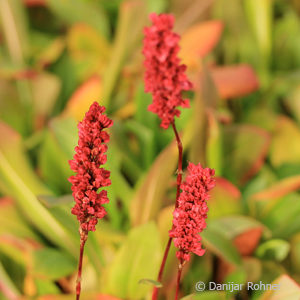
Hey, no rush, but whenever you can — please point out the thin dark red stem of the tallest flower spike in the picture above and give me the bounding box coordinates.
[152,122,183,300]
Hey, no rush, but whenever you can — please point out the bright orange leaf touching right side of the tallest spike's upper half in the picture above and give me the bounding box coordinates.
[180,20,223,67]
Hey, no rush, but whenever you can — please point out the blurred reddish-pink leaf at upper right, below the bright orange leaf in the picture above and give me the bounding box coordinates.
[211,64,259,99]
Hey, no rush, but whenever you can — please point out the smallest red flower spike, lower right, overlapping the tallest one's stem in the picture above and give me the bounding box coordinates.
[169,163,215,261]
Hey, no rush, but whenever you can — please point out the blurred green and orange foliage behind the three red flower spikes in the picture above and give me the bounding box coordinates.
[0,0,300,300]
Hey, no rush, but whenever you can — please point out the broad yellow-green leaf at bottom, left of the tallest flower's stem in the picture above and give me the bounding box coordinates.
[105,223,162,300]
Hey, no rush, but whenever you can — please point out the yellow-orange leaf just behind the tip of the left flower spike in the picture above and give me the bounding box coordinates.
[63,75,102,121]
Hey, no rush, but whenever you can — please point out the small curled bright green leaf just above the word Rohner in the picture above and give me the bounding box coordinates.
[255,239,290,261]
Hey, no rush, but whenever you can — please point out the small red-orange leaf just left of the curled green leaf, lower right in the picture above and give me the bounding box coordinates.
[234,227,263,256]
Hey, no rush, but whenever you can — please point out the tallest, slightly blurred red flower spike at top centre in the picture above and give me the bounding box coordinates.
[143,13,192,129]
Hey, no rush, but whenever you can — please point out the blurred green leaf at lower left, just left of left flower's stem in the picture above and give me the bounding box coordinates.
[32,248,77,280]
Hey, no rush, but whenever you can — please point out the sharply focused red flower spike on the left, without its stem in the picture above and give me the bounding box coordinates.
[69,102,113,232]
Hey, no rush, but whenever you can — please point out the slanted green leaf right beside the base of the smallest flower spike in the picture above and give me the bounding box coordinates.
[201,225,241,266]
